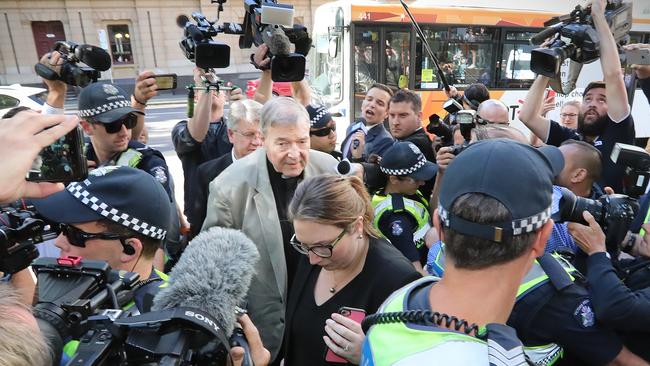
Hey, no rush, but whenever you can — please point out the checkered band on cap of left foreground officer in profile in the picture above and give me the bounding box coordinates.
[66,182,167,239]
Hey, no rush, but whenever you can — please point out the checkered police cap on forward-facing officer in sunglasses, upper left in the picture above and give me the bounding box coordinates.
[79,83,144,123]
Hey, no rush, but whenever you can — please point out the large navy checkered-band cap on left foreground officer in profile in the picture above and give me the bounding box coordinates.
[34,166,171,239]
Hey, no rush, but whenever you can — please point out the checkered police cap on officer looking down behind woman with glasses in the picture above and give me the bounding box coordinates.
[379,141,438,181]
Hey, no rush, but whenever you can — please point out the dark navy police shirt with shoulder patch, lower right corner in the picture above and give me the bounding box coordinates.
[508,276,623,366]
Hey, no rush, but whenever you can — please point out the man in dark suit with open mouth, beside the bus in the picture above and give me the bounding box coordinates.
[341,84,393,161]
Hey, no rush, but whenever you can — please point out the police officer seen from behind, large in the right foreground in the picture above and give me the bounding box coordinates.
[361,139,563,365]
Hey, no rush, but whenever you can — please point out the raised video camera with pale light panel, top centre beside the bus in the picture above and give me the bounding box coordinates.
[239,0,311,81]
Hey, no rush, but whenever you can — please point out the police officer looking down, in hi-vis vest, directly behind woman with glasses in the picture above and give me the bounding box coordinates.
[372,142,437,272]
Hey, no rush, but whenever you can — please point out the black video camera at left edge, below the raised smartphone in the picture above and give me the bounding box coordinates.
[0,206,58,273]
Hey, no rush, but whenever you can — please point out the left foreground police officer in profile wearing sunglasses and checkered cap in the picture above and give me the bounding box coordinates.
[34,166,172,362]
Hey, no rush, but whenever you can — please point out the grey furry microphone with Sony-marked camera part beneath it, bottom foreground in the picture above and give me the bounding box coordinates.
[107,227,259,366]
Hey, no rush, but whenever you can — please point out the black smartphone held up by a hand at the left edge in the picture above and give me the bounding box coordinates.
[26,126,88,183]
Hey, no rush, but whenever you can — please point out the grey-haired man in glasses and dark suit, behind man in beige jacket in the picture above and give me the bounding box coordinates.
[186,100,263,239]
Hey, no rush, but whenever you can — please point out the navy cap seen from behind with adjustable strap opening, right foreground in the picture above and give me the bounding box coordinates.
[438,139,564,242]
